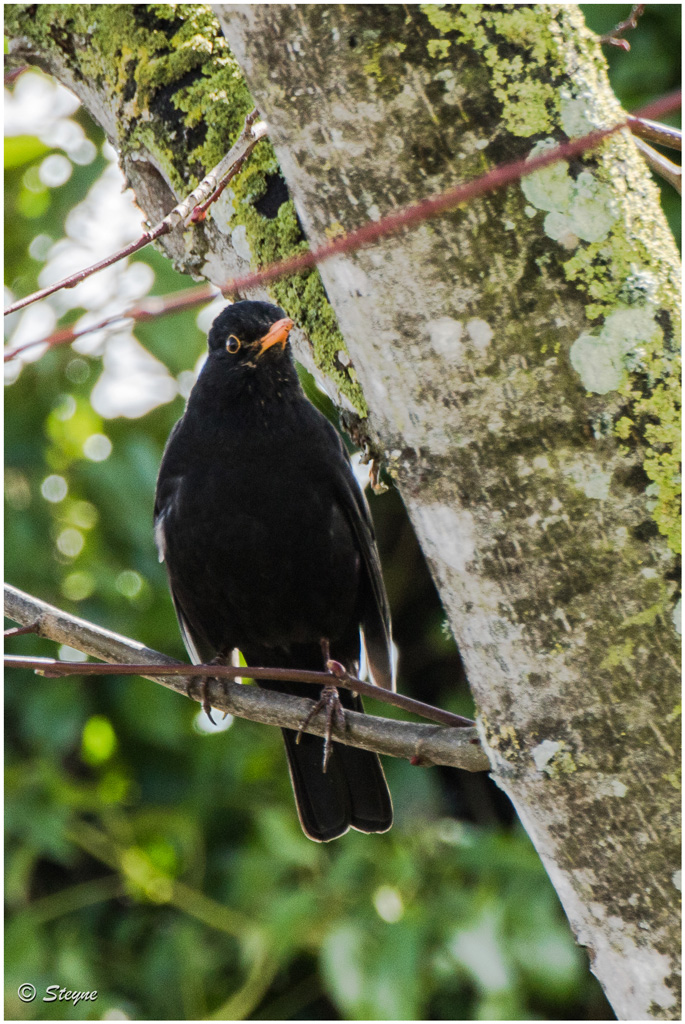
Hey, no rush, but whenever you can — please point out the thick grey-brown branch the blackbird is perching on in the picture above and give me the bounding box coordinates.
[5,584,488,771]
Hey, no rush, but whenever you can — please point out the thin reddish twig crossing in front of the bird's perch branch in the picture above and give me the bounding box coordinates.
[4,651,475,728]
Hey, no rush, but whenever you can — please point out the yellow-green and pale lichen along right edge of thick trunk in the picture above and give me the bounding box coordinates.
[421,4,681,554]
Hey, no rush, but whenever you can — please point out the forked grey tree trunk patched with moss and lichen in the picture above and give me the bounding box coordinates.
[7,4,680,1019]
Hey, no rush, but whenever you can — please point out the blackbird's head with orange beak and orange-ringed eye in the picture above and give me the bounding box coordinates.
[208,301,294,367]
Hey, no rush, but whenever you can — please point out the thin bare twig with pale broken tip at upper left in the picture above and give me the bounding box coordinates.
[5,110,266,316]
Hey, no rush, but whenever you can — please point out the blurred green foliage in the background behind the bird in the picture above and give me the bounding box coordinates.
[5,4,680,1020]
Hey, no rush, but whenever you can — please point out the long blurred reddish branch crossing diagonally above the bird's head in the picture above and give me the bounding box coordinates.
[4,90,682,362]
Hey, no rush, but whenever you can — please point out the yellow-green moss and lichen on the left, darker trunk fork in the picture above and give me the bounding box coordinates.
[5,4,367,417]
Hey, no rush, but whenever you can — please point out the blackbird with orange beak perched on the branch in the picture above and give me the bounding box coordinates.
[155,301,393,842]
